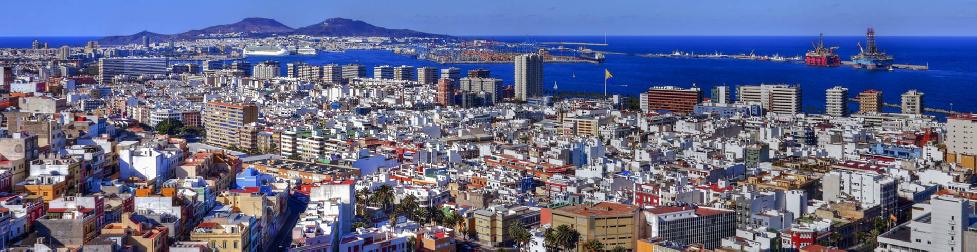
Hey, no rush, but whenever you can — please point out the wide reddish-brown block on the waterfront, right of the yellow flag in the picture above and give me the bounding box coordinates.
[642,86,702,114]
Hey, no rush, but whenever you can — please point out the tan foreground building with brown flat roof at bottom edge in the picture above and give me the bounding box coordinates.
[552,202,638,250]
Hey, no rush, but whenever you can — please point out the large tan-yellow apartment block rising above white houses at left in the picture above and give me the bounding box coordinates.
[203,102,258,148]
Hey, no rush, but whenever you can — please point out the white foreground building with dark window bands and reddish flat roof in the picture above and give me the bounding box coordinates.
[642,206,736,249]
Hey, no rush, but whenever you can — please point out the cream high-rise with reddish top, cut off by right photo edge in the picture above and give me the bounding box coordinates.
[943,114,977,169]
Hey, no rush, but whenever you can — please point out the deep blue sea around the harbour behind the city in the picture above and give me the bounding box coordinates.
[0,36,977,112]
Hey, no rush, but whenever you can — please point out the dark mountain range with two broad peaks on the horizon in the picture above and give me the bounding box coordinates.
[98,17,449,45]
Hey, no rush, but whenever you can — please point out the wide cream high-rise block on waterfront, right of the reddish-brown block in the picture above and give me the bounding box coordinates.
[736,84,801,114]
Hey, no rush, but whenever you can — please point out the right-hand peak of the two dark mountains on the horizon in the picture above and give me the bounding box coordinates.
[293,18,447,37]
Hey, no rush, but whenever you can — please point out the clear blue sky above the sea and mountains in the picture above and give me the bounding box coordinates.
[0,0,977,36]
